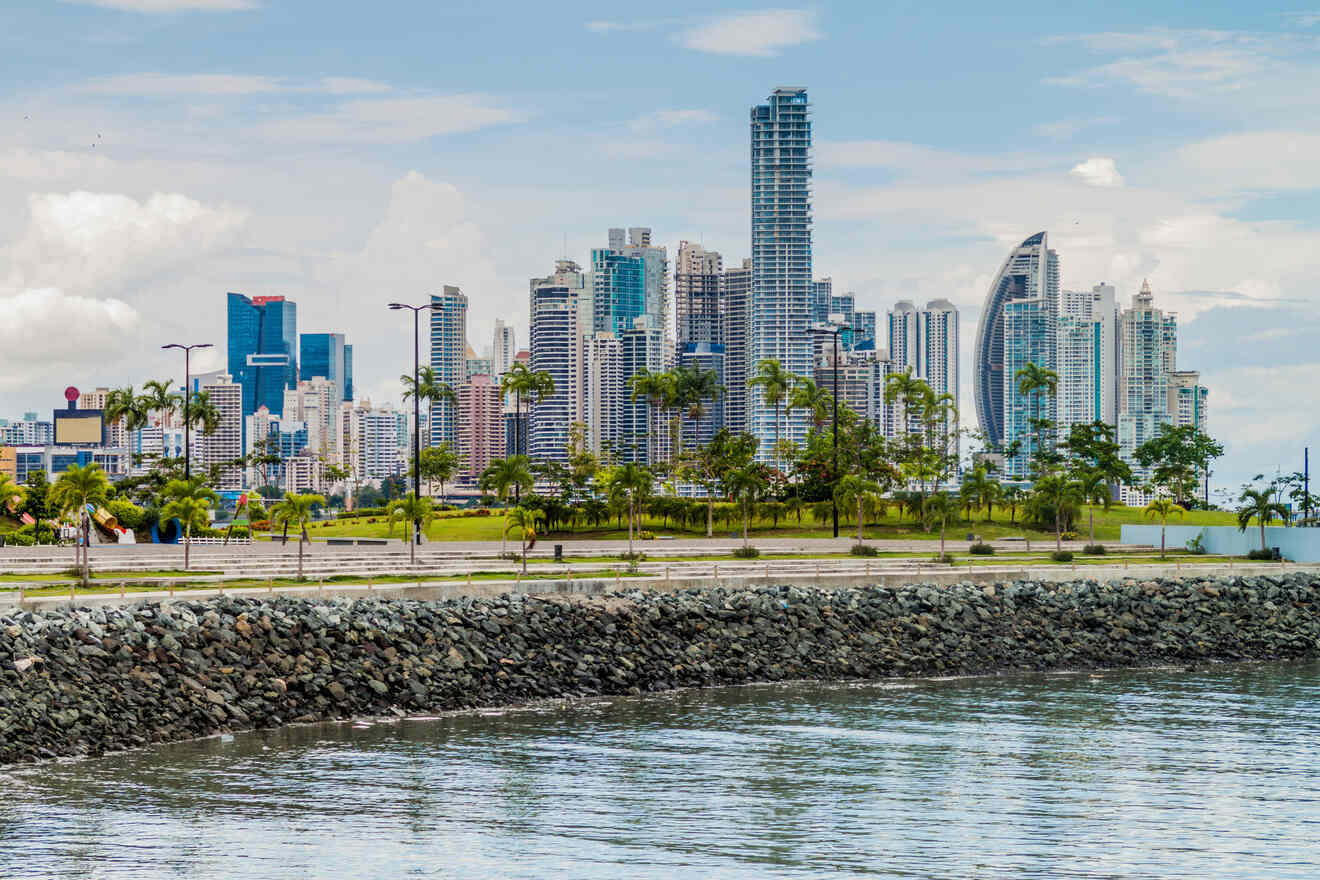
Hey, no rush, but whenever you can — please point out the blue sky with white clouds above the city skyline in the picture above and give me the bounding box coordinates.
[0,0,1320,488]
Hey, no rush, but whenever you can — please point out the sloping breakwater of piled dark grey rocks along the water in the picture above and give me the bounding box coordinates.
[0,574,1320,764]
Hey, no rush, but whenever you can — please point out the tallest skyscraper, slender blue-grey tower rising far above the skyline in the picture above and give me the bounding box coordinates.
[747,88,813,462]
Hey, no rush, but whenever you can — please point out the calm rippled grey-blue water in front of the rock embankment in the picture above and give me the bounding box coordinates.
[0,665,1320,880]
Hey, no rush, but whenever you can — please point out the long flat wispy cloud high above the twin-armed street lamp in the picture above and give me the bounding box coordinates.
[259,95,520,144]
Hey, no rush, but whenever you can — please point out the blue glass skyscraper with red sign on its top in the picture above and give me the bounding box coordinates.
[228,293,298,416]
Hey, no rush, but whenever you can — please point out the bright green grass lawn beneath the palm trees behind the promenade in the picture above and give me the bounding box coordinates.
[294,507,1237,549]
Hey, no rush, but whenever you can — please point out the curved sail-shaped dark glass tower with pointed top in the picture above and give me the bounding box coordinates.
[972,232,1059,450]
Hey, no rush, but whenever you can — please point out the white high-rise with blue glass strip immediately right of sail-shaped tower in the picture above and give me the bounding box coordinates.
[1056,284,1118,439]
